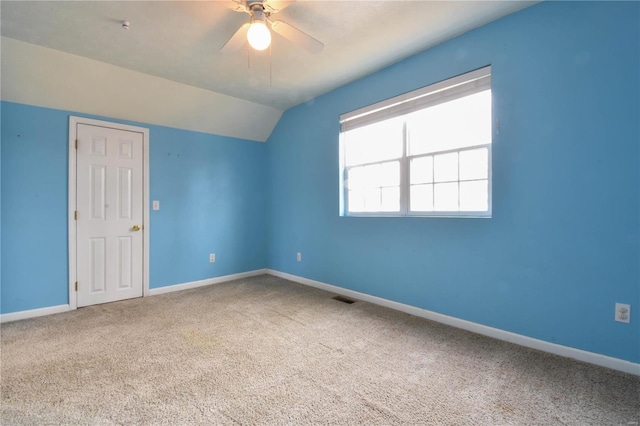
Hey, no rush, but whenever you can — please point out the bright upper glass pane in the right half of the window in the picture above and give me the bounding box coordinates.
[406,90,491,155]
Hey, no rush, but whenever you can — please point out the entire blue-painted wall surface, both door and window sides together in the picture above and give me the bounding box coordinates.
[0,2,640,362]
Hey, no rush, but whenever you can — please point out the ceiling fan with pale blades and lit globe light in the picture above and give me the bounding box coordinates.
[220,0,324,53]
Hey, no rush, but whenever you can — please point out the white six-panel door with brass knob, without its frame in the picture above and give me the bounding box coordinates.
[76,124,144,307]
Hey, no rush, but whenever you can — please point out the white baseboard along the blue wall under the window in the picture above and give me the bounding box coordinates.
[267,269,640,376]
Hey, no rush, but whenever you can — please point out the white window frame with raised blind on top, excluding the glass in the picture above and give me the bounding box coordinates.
[340,66,493,218]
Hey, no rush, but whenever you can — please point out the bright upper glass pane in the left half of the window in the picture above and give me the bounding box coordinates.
[343,117,404,166]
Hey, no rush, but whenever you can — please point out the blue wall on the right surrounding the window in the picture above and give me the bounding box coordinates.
[267,2,640,362]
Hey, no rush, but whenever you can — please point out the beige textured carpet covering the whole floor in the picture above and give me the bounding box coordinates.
[0,276,640,425]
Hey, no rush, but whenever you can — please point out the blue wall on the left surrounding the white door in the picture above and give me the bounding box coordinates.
[0,102,266,313]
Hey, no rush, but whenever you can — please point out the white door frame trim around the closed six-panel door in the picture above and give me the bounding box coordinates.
[67,115,151,309]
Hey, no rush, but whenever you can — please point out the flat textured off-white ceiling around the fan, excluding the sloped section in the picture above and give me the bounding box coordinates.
[0,0,535,110]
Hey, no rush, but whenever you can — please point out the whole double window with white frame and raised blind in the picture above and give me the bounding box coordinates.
[340,67,492,217]
